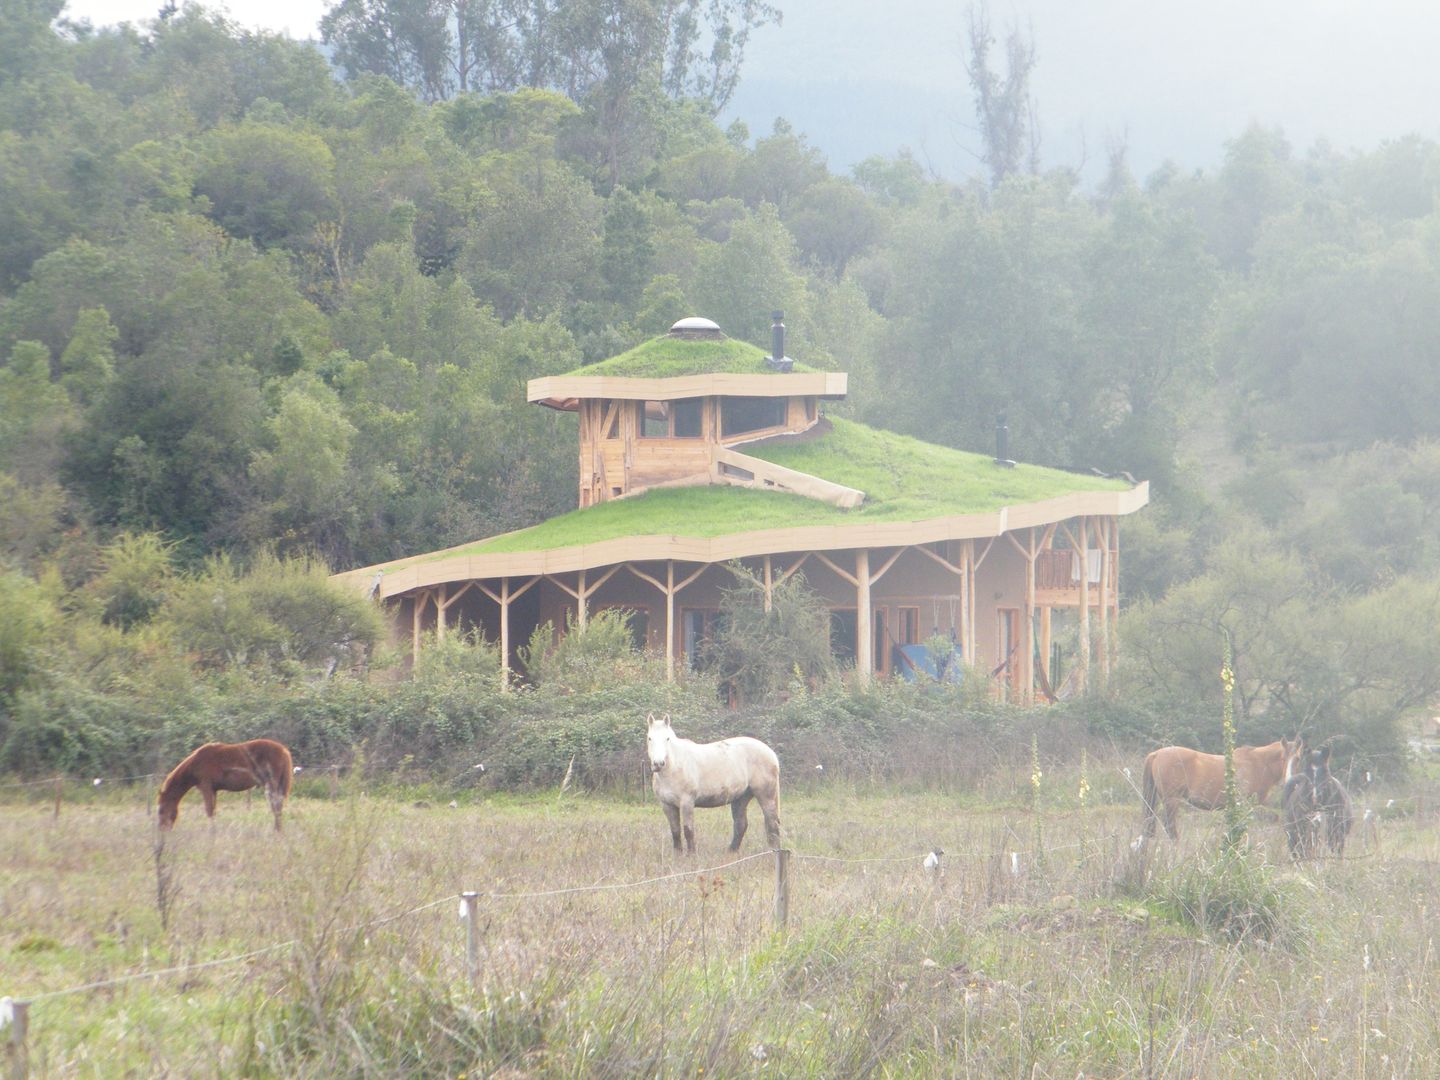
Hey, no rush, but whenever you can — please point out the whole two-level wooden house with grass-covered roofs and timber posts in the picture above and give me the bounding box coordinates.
[337,320,1149,701]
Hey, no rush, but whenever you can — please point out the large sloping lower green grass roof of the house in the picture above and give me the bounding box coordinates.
[420,419,1130,569]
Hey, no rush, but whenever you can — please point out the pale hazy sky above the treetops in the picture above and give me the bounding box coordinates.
[59,0,1440,184]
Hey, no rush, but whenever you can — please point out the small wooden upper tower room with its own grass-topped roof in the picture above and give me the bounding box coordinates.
[527,312,840,507]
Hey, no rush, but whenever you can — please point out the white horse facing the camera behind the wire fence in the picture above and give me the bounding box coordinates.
[645,713,780,855]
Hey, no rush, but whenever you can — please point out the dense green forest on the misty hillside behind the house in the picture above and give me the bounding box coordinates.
[8,0,1440,769]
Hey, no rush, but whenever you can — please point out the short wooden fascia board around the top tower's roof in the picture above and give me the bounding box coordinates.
[526,372,850,412]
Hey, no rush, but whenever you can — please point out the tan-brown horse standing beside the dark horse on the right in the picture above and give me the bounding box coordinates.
[1140,739,1305,842]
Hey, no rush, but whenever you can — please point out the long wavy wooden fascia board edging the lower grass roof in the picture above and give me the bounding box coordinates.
[333,482,1149,599]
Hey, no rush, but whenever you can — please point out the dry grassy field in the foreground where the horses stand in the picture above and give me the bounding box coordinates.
[0,770,1440,1080]
